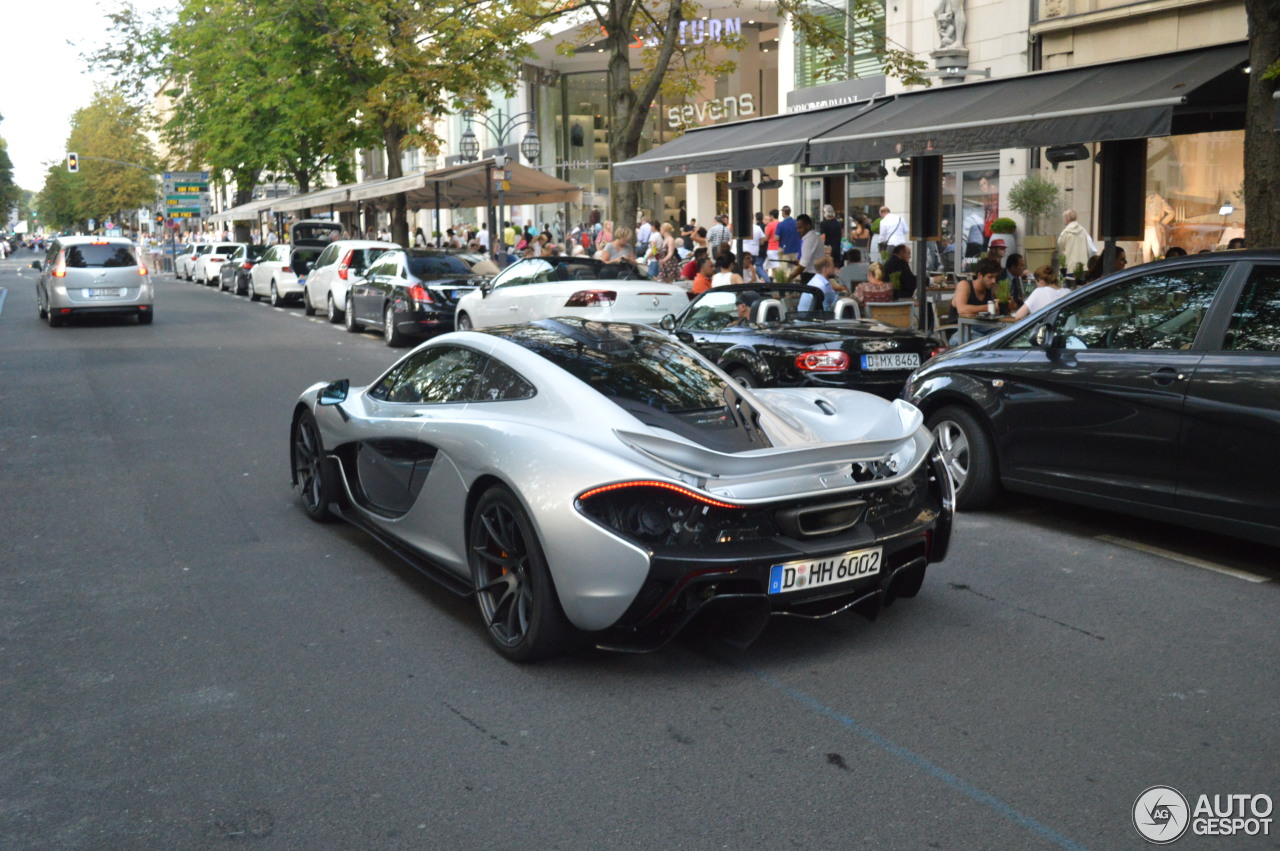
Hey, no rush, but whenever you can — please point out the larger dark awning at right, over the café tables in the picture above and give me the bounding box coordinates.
[797,42,1249,165]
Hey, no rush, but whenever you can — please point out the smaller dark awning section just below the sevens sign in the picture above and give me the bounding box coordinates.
[613,102,868,180]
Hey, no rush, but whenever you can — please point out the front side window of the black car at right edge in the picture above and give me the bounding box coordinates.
[1053,264,1230,351]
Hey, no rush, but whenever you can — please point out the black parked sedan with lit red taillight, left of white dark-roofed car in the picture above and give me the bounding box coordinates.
[344,248,485,347]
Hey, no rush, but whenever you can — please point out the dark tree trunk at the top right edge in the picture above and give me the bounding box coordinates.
[1244,0,1280,248]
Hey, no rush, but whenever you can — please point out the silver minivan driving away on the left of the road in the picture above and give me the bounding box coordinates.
[31,237,155,328]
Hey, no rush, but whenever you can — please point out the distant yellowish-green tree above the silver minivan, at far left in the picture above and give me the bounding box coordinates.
[37,88,157,230]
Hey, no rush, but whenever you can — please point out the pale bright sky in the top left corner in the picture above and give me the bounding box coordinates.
[0,0,173,192]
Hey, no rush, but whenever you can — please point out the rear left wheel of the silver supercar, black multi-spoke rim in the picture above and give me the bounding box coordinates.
[467,485,577,662]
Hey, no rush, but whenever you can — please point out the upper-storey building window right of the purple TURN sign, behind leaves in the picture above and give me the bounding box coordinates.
[796,0,884,88]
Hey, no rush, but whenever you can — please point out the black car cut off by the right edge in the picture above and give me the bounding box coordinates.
[904,251,1280,545]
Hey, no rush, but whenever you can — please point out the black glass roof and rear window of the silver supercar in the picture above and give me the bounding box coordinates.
[493,319,771,452]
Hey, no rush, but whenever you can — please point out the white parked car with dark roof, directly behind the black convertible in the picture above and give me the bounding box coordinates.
[454,257,689,330]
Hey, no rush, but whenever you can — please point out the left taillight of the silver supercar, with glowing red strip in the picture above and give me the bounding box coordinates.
[577,480,769,546]
